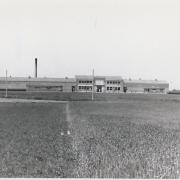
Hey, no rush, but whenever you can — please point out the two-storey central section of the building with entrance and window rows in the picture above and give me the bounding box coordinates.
[76,75,123,93]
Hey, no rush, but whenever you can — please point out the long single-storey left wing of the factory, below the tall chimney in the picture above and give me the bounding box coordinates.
[0,77,76,92]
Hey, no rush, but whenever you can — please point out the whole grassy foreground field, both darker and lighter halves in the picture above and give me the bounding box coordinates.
[0,95,180,178]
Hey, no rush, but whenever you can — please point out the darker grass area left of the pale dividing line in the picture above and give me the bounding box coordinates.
[0,102,75,177]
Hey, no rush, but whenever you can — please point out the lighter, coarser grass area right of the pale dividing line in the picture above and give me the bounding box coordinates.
[71,100,180,178]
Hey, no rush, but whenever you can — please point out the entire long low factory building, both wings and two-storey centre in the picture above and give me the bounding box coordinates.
[0,75,169,94]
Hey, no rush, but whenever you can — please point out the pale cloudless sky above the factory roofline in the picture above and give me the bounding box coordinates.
[0,0,180,89]
